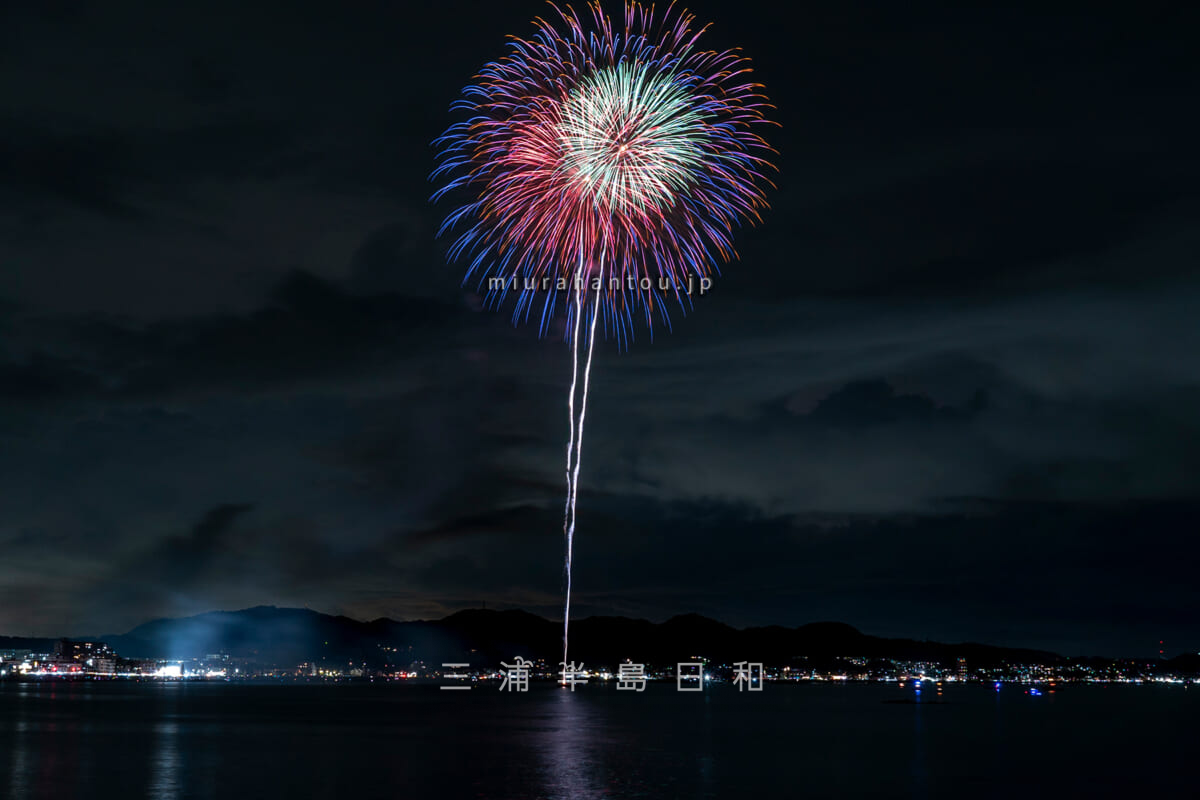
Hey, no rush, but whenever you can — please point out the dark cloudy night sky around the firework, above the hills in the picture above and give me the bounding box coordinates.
[0,0,1200,655]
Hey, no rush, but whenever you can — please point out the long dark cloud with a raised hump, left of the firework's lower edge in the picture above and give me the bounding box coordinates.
[0,271,451,402]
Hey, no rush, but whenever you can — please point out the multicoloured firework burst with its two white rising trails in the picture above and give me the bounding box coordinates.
[431,1,773,669]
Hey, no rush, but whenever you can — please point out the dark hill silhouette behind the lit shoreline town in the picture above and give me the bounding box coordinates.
[0,606,1080,667]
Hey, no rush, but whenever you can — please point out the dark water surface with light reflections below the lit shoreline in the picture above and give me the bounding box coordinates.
[0,681,1200,800]
